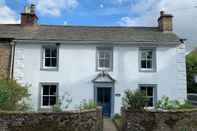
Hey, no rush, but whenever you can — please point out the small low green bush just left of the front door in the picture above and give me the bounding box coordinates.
[80,100,97,110]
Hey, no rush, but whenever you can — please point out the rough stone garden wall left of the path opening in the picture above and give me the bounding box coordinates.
[0,108,103,131]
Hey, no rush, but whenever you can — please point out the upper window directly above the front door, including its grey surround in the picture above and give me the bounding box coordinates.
[96,47,113,71]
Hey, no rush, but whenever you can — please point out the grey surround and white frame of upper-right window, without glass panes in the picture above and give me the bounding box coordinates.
[139,47,156,72]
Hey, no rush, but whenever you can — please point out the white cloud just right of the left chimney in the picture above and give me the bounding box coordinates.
[31,0,79,16]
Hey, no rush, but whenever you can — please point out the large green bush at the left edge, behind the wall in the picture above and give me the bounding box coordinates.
[0,80,30,111]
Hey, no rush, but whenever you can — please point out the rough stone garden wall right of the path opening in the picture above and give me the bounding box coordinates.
[122,109,197,131]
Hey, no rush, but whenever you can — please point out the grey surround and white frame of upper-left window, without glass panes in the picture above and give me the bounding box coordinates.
[41,45,59,70]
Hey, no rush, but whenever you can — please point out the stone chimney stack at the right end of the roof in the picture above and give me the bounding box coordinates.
[158,11,173,32]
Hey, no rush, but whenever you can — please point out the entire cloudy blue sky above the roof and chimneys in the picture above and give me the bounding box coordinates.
[0,0,197,48]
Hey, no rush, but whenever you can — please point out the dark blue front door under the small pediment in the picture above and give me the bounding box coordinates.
[97,88,111,117]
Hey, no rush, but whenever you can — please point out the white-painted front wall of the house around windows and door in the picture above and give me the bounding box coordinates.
[14,43,186,113]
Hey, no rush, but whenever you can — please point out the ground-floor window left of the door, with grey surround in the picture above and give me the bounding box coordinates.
[41,83,58,107]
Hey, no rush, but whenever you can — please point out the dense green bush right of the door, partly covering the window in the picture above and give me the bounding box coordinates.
[122,90,148,110]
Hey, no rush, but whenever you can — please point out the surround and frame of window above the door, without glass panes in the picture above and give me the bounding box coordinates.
[96,47,113,71]
